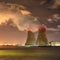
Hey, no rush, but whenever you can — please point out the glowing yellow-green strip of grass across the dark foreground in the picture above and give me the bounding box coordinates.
[0,50,55,56]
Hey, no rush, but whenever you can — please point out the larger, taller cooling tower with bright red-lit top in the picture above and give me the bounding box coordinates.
[36,26,48,46]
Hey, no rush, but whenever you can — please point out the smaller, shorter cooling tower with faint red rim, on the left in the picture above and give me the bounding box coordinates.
[25,31,35,46]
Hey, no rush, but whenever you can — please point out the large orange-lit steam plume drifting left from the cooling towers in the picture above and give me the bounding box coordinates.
[0,3,40,31]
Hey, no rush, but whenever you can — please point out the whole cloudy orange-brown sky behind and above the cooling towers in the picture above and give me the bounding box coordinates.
[0,0,60,44]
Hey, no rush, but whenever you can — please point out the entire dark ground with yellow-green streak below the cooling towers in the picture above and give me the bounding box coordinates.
[0,47,60,60]
